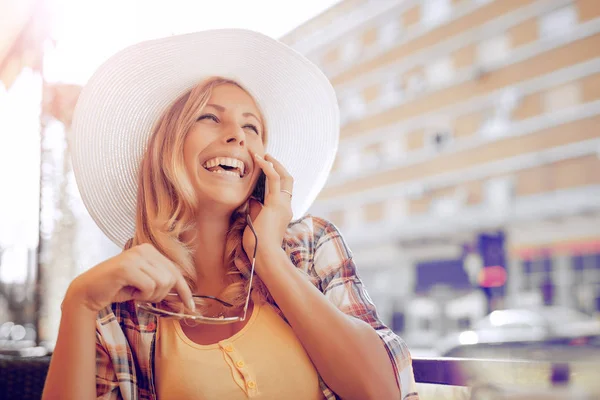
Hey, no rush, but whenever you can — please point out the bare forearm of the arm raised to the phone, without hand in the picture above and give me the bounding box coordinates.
[257,250,400,399]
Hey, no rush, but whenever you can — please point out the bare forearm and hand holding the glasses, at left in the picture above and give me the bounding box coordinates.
[42,244,193,400]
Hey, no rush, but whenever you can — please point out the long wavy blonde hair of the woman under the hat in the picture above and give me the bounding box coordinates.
[125,77,270,308]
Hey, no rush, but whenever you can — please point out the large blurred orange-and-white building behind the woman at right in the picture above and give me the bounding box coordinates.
[283,0,600,345]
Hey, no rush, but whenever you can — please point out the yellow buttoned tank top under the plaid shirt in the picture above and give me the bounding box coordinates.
[155,303,324,400]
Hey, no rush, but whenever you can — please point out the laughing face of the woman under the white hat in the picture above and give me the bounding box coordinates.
[184,84,265,211]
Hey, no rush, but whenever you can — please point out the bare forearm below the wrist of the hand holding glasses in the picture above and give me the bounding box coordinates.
[42,292,96,400]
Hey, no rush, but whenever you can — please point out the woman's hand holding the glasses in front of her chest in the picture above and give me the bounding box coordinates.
[65,243,194,313]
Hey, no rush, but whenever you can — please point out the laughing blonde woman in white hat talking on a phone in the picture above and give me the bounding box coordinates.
[44,29,418,399]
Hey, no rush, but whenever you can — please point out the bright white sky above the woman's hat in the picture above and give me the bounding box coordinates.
[46,0,339,83]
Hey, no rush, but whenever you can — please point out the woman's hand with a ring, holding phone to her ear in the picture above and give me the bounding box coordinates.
[243,154,294,259]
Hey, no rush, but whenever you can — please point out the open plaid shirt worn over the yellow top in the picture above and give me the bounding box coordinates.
[96,216,418,400]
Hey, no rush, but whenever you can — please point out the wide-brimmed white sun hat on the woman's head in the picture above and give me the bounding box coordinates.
[69,29,339,247]
